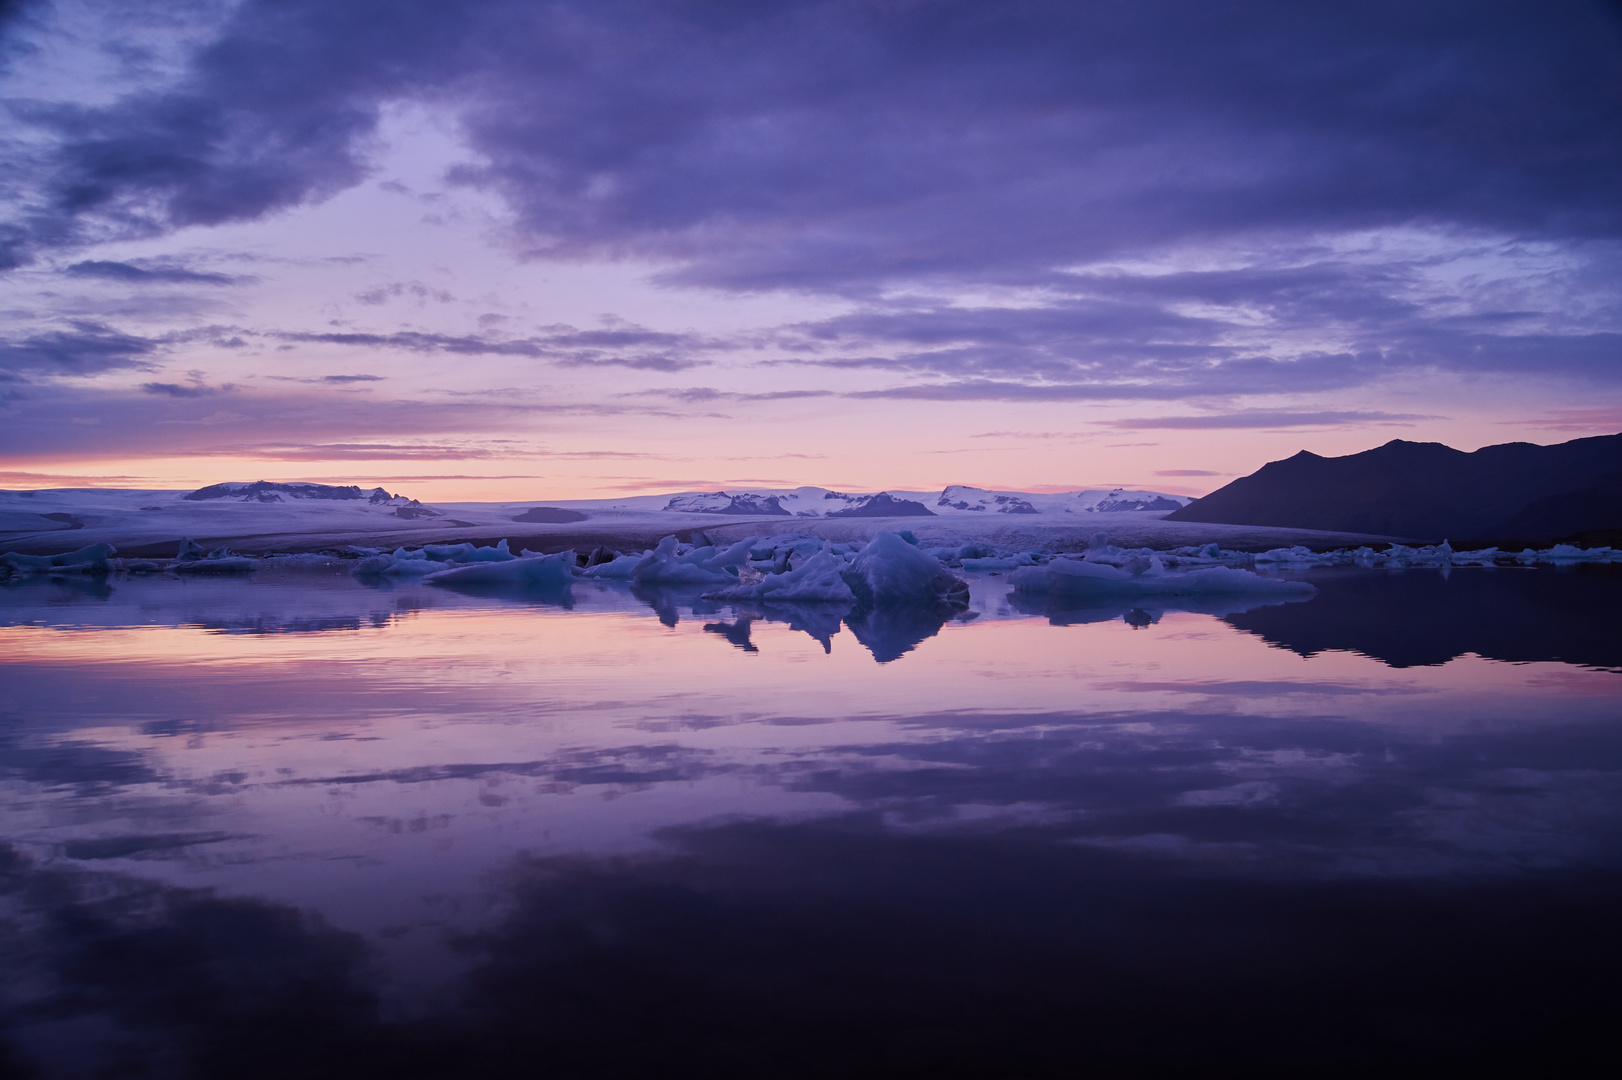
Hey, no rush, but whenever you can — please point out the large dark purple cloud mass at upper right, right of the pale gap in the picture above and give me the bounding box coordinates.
[444,3,1622,289]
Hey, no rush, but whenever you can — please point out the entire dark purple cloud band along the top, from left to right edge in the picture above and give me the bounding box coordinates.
[11,0,1622,277]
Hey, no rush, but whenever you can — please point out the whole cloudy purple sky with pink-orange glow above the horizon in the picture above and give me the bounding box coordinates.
[0,0,1622,501]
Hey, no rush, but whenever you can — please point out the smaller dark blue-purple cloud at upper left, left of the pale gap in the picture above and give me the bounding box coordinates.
[0,3,433,264]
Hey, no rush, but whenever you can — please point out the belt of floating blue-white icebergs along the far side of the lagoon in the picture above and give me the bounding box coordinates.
[9,530,1622,608]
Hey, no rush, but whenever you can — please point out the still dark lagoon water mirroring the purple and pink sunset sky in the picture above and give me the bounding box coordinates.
[0,568,1622,1077]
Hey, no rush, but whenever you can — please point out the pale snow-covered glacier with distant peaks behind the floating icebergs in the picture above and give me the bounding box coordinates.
[0,482,1398,558]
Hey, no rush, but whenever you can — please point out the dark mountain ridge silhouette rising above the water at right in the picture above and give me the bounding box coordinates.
[1166,435,1622,540]
